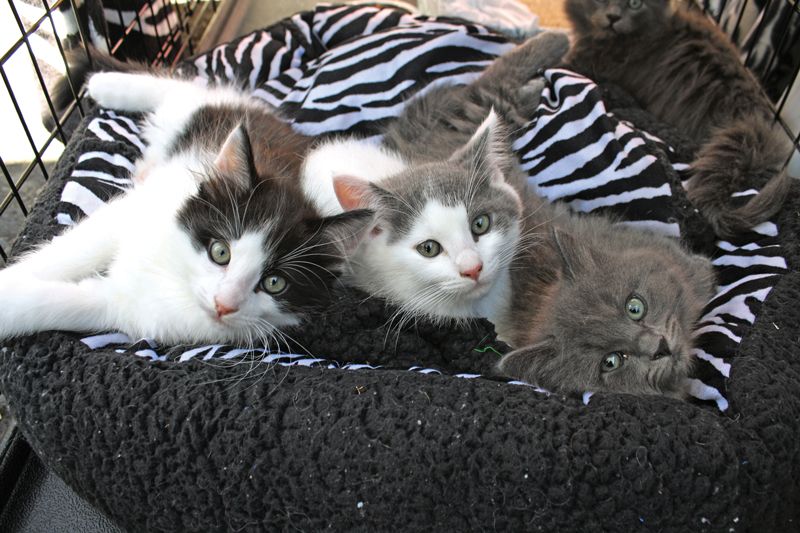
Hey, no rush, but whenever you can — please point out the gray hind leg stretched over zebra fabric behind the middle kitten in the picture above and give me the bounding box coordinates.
[475,31,569,87]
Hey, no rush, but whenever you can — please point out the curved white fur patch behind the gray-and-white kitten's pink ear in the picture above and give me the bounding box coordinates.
[300,139,407,216]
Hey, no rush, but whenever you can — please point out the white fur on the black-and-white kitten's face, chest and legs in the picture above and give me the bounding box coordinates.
[0,74,299,343]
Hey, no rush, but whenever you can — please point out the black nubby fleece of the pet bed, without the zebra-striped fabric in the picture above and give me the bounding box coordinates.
[0,8,800,532]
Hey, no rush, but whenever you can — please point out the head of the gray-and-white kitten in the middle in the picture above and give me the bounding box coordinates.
[324,113,522,320]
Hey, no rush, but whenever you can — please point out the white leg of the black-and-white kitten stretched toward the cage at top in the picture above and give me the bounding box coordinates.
[86,72,203,113]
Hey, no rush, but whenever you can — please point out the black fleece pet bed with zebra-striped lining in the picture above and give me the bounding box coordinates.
[0,5,800,532]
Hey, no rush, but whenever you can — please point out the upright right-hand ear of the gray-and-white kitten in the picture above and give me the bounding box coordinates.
[450,108,508,183]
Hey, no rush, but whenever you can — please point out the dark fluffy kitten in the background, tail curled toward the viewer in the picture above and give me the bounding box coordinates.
[566,0,791,237]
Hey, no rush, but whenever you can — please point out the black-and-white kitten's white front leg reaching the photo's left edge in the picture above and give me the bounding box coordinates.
[0,277,114,339]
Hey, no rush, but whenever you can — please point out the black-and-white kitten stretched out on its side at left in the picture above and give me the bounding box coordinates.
[0,72,370,345]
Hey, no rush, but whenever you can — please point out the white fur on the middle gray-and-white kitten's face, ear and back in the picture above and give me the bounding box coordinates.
[302,110,521,322]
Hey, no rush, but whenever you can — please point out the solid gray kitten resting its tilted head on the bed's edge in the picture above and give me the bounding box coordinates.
[497,202,714,397]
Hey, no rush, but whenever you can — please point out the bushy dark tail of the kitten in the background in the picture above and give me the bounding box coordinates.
[687,119,793,237]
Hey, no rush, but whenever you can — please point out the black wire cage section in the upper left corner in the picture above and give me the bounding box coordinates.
[0,0,222,266]
